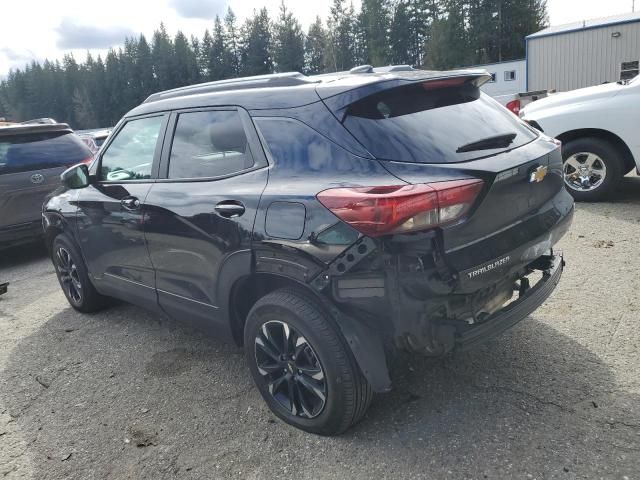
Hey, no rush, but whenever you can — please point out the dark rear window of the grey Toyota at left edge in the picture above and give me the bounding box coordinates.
[0,132,92,175]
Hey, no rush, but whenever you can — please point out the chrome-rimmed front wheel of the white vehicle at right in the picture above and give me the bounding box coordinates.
[562,137,625,202]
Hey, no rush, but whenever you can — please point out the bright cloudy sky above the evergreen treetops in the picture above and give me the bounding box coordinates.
[0,0,640,78]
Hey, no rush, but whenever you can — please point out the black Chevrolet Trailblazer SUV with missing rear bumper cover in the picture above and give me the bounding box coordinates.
[44,67,573,434]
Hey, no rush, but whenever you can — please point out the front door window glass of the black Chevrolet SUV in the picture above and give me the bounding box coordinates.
[100,116,163,182]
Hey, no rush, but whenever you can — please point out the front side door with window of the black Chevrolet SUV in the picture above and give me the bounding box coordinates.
[77,114,168,308]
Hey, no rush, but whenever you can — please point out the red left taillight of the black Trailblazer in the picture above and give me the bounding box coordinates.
[318,179,483,237]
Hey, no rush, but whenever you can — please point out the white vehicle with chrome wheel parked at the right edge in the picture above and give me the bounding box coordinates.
[521,77,640,202]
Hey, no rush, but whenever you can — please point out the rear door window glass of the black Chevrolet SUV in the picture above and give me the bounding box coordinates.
[169,110,253,179]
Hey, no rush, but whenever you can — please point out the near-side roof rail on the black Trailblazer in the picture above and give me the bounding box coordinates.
[143,72,319,103]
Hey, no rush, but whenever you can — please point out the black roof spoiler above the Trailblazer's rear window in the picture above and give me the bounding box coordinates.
[316,70,491,121]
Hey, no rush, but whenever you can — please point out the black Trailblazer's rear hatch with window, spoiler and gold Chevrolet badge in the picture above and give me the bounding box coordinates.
[325,72,572,286]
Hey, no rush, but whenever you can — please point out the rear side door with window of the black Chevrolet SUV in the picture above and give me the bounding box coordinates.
[145,109,267,336]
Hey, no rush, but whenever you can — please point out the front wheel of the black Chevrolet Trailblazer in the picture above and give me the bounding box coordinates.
[51,233,109,313]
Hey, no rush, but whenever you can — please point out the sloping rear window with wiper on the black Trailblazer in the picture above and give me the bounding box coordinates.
[344,82,536,163]
